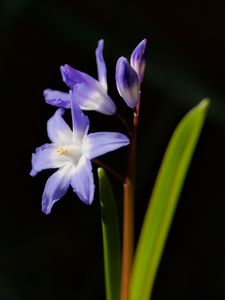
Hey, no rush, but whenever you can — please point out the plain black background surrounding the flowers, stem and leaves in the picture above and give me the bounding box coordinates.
[0,0,225,300]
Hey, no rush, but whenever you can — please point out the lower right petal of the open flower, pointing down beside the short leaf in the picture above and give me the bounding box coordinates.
[71,156,95,204]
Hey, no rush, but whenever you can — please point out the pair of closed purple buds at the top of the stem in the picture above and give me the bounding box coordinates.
[116,39,147,108]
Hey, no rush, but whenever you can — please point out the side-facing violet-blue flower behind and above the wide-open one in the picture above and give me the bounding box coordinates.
[44,40,116,115]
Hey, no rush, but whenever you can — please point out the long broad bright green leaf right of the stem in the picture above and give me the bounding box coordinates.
[130,99,209,300]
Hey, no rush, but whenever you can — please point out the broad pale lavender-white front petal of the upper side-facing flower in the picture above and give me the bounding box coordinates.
[73,83,116,115]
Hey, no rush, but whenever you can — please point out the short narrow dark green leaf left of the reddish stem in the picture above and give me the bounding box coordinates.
[98,168,121,300]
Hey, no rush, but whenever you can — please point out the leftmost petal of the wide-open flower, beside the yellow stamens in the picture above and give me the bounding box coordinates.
[30,144,67,176]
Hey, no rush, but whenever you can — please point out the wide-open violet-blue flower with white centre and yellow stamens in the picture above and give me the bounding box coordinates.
[30,101,129,214]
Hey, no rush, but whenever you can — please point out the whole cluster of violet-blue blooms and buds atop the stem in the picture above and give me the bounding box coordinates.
[30,40,146,214]
